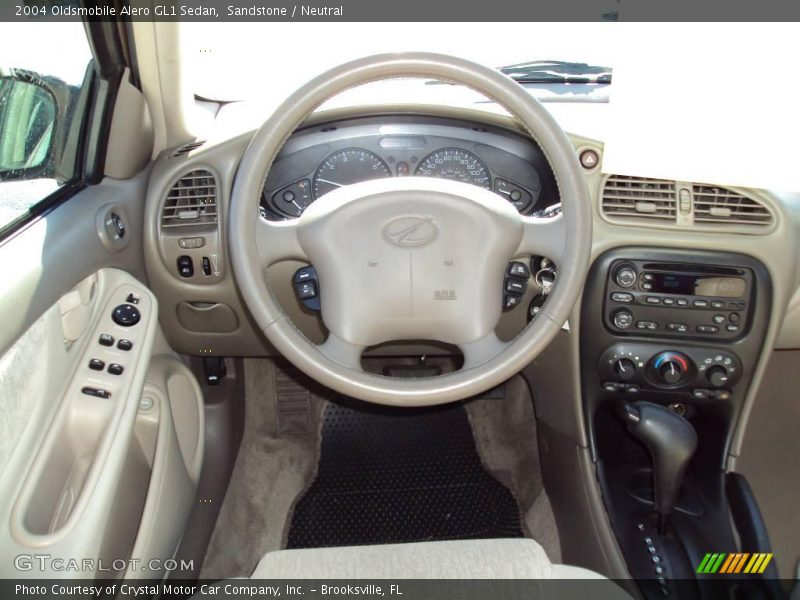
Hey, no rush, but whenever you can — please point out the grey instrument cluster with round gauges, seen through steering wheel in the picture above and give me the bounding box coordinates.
[260,116,559,220]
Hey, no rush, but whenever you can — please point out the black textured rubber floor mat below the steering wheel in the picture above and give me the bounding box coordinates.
[287,403,523,548]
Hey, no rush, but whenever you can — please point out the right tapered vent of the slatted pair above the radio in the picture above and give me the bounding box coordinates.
[692,185,773,227]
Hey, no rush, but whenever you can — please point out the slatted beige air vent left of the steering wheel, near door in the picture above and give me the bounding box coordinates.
[161,169,218,229]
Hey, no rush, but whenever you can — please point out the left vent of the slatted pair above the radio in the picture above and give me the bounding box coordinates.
[602,175,676,222]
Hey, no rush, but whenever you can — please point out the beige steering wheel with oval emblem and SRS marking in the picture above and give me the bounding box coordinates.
[229,53,592,406]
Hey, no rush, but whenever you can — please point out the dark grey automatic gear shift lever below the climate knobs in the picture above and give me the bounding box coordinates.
[623,402,697,533]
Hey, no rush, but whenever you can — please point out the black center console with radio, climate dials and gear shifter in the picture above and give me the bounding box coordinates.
[580,247,777,598]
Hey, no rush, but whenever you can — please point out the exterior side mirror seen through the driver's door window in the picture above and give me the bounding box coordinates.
[0,69,77,181]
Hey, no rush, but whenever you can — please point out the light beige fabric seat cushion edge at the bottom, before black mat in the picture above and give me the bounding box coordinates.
[252,538,616,579]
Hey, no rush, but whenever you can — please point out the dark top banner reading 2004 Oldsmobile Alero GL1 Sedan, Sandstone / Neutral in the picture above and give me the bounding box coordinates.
[0,0,800,21]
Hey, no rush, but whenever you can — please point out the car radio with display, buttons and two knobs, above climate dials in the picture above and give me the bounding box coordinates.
[603,260,754,340]
